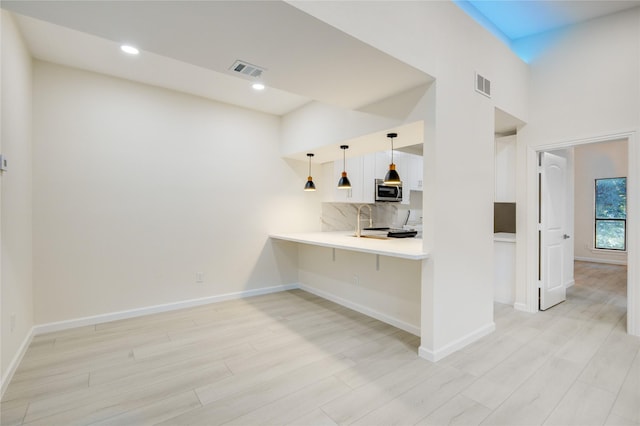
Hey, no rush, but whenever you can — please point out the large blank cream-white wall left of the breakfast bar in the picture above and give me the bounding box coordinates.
[33,62,321,324]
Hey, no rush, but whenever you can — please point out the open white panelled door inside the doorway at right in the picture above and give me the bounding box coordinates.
[540,152,569,311]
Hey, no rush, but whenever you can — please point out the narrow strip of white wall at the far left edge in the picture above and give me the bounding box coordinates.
[0,11,33,390]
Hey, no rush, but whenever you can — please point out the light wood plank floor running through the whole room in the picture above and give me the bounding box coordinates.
[2,262,640,426]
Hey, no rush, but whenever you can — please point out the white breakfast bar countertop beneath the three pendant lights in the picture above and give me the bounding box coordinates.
[269,231,429,260]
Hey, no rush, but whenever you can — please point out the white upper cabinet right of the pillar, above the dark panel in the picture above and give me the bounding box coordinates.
[495,135,517,203]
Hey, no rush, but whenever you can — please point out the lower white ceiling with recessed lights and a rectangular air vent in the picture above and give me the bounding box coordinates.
[2,0,432,115]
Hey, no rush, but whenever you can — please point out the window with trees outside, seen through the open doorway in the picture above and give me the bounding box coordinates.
[595,178,627,250]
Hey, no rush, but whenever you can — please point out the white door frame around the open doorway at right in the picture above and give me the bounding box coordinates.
[514,131,640,336]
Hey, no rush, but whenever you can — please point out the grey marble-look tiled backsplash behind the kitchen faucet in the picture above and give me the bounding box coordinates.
[322,203,416,232]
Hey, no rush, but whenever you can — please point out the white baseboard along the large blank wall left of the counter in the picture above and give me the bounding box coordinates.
[33,284,299,336]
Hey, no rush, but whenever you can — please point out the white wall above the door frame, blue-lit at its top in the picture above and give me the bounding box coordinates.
[519,8,640,145]
